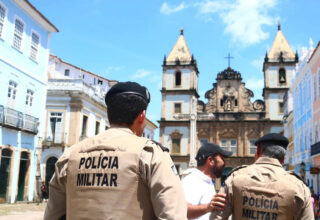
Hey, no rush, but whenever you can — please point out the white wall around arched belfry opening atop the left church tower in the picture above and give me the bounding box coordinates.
[165,69,191,90]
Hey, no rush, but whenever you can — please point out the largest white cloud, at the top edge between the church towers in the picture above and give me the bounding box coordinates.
[196,0,278,46]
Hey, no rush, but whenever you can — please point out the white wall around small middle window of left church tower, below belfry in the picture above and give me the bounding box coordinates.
[164,95,190,120]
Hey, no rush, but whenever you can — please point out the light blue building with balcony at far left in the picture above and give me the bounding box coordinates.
[0,0,58,203]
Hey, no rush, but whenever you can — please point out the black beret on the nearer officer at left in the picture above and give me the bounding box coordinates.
[105,82,150,104]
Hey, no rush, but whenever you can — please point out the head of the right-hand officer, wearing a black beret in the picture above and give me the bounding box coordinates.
[255,133,289,161]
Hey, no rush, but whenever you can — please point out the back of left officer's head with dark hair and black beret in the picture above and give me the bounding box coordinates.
[105,82,150,125]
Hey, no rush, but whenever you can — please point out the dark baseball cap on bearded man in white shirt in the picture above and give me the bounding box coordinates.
[196,143,232,161]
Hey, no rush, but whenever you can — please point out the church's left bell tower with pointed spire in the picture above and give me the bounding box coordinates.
[159,29,199,170]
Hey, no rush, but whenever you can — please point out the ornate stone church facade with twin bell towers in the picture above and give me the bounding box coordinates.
[159,27,297,183]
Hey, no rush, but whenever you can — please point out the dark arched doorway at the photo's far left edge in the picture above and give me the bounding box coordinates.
[0,149,12,203]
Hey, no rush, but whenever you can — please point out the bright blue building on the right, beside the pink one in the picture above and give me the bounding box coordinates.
[291,42,315,188]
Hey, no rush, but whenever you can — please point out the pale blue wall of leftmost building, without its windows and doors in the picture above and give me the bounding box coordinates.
[0,0,51,203]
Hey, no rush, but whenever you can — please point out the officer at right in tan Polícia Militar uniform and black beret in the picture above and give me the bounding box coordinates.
[210,133,314,220]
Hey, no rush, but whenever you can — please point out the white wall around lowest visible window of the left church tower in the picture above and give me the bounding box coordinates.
[163,127,189,155]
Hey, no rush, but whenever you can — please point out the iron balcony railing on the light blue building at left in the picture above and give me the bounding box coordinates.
[0,105,39,133]
